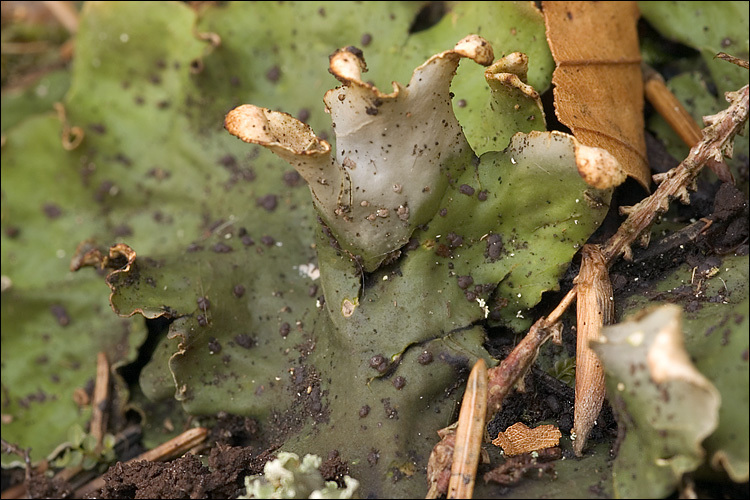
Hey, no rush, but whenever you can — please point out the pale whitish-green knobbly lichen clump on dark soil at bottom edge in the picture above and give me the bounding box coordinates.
[238,451,359,498]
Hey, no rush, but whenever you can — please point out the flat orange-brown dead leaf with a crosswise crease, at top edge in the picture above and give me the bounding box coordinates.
[543,2,651,189]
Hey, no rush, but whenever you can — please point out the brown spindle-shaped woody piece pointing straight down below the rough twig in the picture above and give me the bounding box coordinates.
[573,245,615,456]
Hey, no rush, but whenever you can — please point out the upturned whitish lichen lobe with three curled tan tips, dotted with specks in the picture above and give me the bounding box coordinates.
[225,35,494,271]
